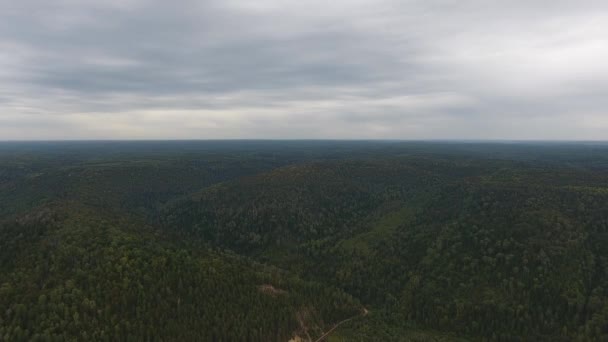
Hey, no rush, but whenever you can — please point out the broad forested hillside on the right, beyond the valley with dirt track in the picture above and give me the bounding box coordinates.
[166,154,608,340]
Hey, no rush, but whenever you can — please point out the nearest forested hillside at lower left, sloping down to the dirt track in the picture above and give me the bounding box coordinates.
[0,203,362,341]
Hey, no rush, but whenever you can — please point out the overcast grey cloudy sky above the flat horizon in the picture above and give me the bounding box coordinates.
[0,0,608,140]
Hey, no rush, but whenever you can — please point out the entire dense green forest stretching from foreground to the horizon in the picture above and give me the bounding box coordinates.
[0,141,608,341]
